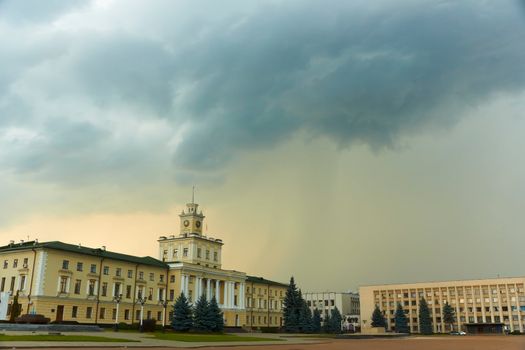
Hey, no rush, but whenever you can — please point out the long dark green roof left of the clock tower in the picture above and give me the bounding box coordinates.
[0,241,168,269]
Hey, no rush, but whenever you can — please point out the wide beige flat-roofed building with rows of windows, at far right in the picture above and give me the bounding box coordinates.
[359,277,525,333]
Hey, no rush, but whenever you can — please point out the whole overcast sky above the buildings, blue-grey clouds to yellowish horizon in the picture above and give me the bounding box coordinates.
[0,0,525,291]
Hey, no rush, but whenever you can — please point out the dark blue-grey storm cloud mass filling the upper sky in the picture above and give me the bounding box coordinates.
[0,1,525,182]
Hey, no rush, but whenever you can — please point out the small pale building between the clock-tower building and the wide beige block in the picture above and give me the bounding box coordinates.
[303,292,360,330]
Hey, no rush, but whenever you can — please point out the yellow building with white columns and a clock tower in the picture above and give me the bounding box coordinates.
[0,203,286,328]
